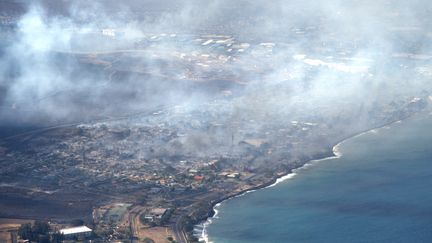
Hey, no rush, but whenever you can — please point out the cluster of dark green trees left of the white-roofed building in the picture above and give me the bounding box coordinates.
[18,220,64,243]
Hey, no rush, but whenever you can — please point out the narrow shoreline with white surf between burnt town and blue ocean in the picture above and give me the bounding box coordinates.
[196,117,408,243]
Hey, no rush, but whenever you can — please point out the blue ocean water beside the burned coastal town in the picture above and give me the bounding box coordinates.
[206,116,432,243]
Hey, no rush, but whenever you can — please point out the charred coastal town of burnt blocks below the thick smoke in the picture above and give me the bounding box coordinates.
[1,80,430,242]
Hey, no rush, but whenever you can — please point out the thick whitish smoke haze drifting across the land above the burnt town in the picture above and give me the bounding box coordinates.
[0,0,432,132]
